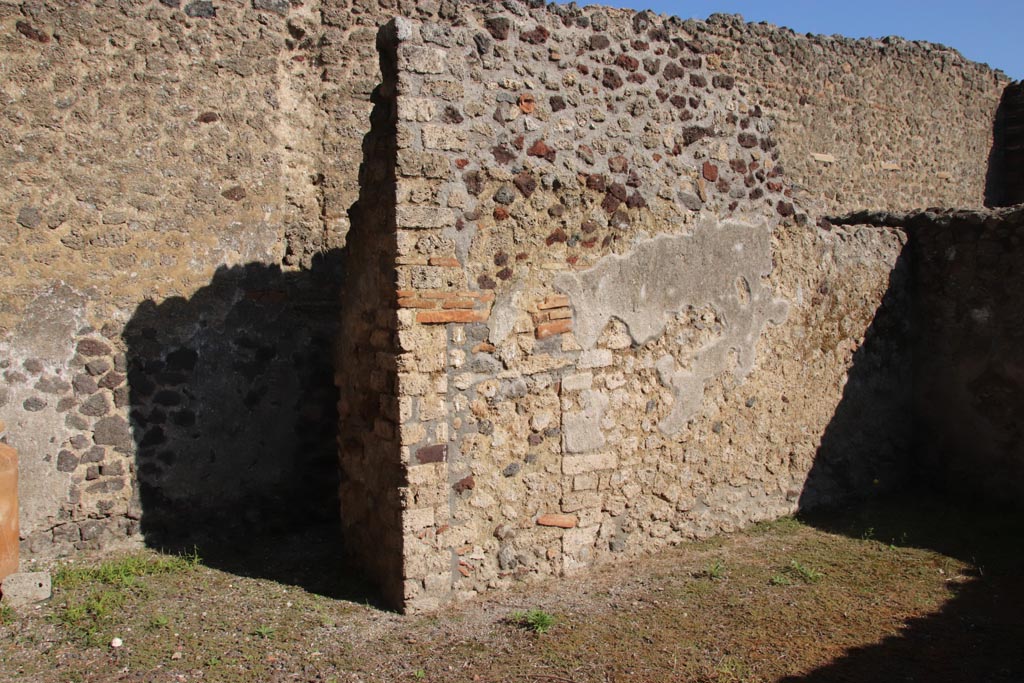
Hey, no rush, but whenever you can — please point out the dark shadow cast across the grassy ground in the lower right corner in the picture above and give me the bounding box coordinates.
[782,492,1024,683]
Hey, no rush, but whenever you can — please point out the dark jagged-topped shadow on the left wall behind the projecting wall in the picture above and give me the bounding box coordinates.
[124,251,373,601]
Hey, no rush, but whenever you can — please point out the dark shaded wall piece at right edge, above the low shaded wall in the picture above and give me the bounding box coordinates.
[985,81,1024,207]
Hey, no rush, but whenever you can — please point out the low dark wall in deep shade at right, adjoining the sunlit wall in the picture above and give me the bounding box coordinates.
[844,207,1024,507]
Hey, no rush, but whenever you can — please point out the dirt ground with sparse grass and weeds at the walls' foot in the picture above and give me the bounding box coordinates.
[0,496,1024,683]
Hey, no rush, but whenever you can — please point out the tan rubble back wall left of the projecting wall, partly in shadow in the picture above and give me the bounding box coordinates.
[0,1,344,556]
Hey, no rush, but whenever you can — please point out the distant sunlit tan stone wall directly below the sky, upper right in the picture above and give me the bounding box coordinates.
[696,15,1009,213]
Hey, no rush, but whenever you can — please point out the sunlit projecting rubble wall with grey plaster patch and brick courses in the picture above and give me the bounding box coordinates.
[385,5,907,610]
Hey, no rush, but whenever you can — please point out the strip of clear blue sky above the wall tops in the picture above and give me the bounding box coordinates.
[584,0,1024,79]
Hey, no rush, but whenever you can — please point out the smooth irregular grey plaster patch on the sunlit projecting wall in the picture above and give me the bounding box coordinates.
[555,216,788,434]
